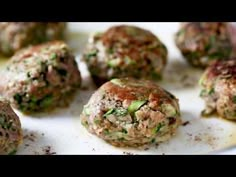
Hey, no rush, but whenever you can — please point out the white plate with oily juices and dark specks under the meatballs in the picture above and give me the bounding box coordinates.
[1,23,236,154]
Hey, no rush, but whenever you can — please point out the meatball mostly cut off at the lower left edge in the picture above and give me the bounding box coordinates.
[0,98,22,155]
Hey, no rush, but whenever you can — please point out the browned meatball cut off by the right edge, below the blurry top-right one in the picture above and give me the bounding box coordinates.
[200,59,236,120]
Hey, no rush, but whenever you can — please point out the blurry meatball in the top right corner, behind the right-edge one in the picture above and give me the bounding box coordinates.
[175,22,233,68]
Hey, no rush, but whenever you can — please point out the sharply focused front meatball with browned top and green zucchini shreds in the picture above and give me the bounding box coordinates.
[81,78,181,147]
